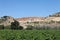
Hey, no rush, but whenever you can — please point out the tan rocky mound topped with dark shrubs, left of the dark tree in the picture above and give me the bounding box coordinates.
[0,16,14,26]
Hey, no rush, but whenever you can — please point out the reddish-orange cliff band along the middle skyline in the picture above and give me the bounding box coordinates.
[16,17,45,22]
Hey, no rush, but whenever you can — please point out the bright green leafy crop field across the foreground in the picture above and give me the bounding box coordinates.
[0,30,60,40]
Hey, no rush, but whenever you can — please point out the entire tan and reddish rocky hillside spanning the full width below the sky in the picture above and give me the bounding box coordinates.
[0,12,60,27]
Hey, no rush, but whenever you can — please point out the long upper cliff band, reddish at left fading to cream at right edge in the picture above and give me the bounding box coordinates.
[16,17,60,23]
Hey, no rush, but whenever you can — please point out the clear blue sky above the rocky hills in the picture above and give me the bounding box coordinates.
[0,0,60,18]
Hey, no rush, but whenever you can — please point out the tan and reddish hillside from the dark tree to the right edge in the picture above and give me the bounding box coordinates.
[16,12,60,28]
